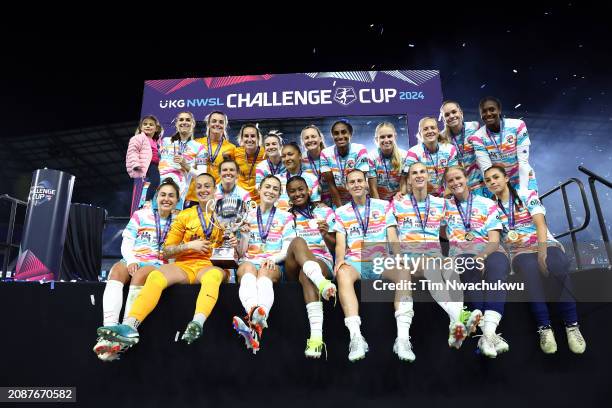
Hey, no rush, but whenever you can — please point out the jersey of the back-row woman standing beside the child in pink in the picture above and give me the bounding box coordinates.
[159,137,208,210]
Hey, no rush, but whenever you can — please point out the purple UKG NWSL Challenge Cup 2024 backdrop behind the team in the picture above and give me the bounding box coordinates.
[142,70,442,149]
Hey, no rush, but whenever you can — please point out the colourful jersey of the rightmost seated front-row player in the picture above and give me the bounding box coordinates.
[497,190,559,255]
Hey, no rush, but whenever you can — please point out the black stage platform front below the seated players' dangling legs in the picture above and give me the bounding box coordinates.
[0,283,612,408]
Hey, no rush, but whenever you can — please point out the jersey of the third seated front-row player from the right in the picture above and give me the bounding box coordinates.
[393,194,445,255]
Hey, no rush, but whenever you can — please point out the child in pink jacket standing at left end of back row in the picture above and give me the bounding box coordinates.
[125,115,164,216]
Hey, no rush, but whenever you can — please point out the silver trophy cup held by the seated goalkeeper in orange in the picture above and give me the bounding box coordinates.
[210,197,246,269]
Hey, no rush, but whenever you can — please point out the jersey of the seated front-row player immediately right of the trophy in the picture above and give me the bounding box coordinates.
[242,207,295,266]
